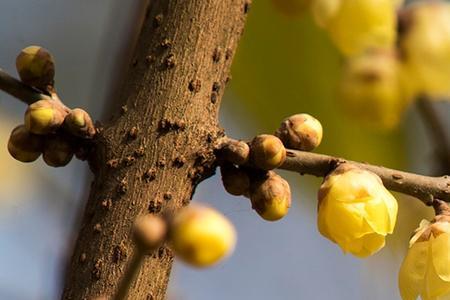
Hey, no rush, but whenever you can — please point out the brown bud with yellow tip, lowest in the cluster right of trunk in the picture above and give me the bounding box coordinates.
[250,171,291,221]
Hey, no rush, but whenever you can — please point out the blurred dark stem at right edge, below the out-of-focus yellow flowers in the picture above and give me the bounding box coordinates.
[417,96,450,173]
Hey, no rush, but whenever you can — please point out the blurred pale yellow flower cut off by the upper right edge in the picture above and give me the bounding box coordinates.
[399,1,450,97]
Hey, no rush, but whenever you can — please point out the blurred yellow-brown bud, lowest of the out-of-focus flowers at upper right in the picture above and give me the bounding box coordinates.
[338,49,411,129]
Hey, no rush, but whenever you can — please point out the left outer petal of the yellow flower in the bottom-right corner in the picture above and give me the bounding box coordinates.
[399,242,430,300]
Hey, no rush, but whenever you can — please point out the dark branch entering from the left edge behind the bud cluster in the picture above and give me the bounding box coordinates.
[0,69,51,104]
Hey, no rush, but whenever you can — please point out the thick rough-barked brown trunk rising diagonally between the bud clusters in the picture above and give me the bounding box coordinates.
[62,0,249,299]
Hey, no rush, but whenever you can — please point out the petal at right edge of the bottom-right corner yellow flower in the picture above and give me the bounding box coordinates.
[431,233,450,282]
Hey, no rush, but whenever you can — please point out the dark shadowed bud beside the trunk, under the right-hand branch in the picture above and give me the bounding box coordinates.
[220,164,250,196]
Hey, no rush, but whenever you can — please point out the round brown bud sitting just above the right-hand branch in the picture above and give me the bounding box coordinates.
[275,114,323,151]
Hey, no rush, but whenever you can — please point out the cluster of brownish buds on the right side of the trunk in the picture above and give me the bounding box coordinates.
[220,114,322,221]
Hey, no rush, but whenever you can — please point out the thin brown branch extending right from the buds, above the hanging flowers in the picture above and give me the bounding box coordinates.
[221,139,450,205]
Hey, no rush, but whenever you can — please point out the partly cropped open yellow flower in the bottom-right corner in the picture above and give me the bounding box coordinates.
[399,216,450,300]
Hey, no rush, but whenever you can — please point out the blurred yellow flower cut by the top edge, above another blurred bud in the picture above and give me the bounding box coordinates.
[311,0,396,55]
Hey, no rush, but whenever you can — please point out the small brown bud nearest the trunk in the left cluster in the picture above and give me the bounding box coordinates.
[64,108,95,138]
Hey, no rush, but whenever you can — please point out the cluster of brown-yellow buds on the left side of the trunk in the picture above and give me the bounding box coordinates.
[8,46,95,167]
